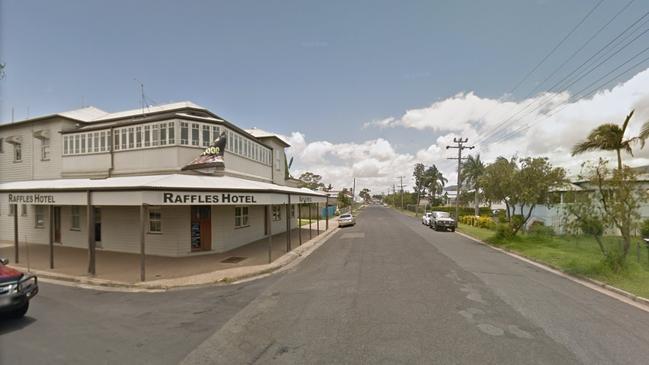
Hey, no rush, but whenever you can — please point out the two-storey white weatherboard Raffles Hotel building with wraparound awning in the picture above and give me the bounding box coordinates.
[0,102,326,273]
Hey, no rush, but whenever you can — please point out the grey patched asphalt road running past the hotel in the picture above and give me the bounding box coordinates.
[0,207,649,364]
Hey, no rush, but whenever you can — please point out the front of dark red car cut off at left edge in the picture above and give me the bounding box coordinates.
[0,259,38,318]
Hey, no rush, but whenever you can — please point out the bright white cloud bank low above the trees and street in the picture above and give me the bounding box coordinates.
[287,70,649,192]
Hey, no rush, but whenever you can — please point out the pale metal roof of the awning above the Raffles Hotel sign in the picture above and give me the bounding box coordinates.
[0,174,326,197]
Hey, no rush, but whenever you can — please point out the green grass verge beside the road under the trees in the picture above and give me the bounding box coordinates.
[458,224,649,298]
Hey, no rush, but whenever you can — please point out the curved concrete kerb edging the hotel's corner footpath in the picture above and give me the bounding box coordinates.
[15,221,339,292]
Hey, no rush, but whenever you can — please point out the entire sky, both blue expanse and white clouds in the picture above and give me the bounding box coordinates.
[0,0,649,193]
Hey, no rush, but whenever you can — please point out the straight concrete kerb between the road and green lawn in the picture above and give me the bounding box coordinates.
[455,232,649,312]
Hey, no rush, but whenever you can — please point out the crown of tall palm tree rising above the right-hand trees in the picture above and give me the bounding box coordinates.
[572,110,649,170]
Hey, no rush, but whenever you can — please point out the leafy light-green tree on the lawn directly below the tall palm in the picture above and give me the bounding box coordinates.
[566,158,649,272]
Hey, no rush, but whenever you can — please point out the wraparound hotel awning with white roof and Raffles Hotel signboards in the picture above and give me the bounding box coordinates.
[0,174,327,205]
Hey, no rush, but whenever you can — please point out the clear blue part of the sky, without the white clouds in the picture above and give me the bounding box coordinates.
[0,0,649,191]
